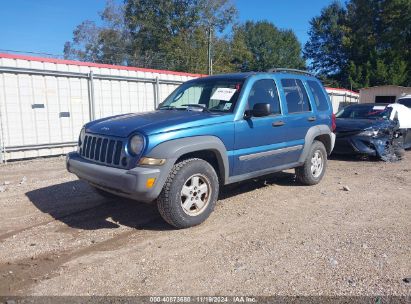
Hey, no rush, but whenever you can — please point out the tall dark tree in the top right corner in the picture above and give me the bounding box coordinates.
[347,0,411,86]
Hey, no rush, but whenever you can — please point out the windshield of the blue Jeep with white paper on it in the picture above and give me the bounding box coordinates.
[158,78,244,112]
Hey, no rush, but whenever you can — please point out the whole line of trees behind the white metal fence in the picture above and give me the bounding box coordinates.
[64,0,411,89]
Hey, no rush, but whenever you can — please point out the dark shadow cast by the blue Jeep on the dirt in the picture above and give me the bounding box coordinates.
[26,172,299,230]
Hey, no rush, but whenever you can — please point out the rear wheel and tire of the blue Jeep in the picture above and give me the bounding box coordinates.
[295,140,327,186]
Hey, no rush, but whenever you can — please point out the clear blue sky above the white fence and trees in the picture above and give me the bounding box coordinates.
[0,0,331,56]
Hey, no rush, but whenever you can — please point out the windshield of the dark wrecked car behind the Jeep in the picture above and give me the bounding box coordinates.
[335,105,391,119]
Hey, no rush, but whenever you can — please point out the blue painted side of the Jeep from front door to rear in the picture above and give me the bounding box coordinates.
[229,73,331,175]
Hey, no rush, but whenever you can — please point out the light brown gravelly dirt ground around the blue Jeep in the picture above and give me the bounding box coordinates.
[0,152,411,296]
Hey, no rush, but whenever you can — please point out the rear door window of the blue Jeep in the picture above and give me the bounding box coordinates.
[281,79,311,113]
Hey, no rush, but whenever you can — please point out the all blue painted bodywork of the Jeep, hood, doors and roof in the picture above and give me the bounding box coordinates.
[86,73,332,176]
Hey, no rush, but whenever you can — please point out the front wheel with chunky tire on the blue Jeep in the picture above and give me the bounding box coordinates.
[157,158,219,229]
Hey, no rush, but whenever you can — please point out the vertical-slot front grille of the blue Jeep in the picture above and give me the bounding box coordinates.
[80,134,123,166]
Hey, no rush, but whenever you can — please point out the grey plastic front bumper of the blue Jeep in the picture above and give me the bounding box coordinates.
[66,152,168,203]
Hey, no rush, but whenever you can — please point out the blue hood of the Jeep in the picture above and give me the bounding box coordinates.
[86,110,227,137]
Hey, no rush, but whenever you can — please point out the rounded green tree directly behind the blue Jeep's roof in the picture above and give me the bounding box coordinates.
[232,21,305,71]
